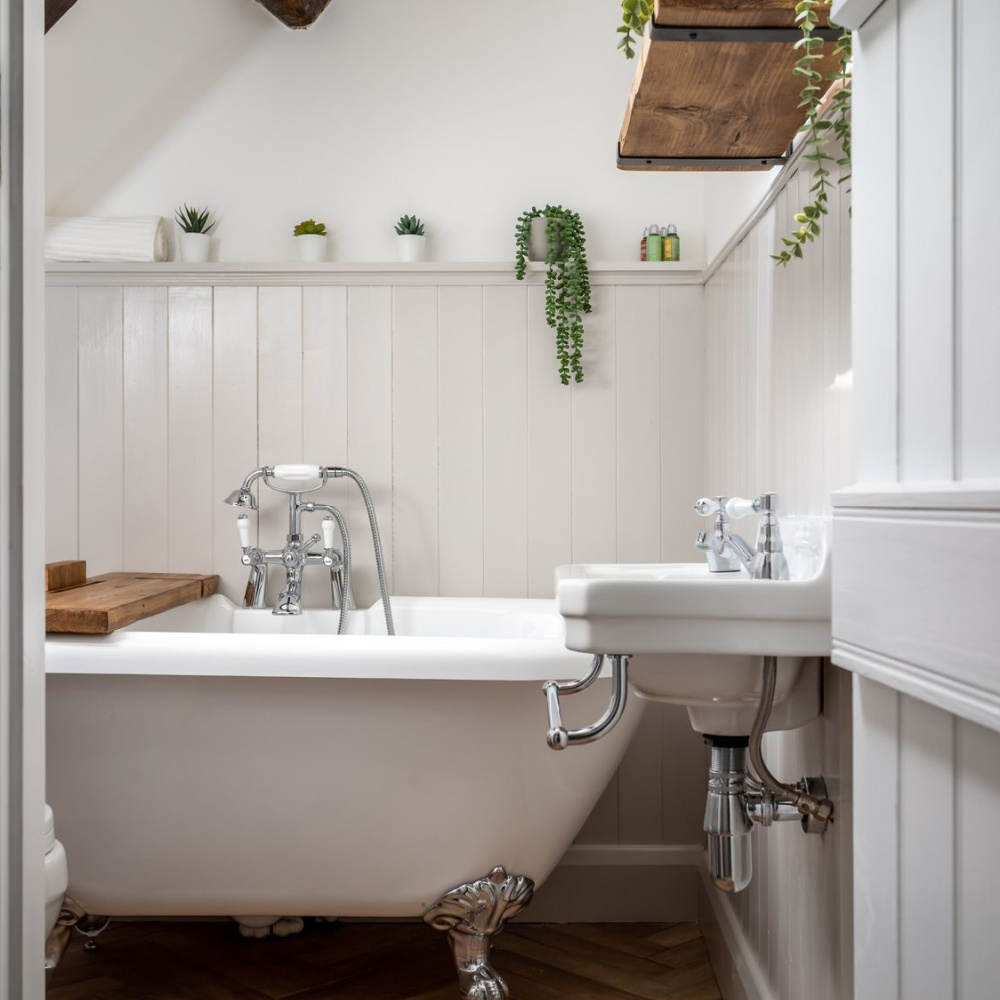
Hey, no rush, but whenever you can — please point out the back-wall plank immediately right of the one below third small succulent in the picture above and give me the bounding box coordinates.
[437,287,484,597]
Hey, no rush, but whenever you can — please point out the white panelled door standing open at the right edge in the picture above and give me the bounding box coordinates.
[833,0,1000,1000]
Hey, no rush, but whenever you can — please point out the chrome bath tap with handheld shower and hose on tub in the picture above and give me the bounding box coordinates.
[225,465,395,635]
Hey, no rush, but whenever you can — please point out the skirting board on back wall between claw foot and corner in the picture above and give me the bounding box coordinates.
[518,844,704,923]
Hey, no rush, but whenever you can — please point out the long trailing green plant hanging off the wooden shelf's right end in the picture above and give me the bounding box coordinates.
[771,0,851,267]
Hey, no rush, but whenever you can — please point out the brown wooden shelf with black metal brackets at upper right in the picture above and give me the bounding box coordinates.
[618,0,837,170]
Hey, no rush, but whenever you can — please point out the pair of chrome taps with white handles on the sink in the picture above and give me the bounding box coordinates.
[694,493,788,580]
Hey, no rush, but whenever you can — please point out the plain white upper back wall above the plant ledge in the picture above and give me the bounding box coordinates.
[46,0,728,261]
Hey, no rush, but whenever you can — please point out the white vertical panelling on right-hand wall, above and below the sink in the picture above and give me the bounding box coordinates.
[703,156,856,1000]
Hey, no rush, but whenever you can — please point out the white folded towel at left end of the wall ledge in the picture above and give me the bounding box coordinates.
[45,215,170,263]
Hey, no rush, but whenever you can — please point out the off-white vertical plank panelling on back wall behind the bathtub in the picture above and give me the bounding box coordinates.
[46,272,705,856]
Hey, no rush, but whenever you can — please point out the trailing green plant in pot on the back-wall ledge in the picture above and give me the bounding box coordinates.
[514,205,591,385]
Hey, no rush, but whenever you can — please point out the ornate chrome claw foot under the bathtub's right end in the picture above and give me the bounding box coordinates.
[424,865,535,1000]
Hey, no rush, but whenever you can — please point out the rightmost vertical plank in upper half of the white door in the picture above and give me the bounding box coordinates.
[955,0,1000,479]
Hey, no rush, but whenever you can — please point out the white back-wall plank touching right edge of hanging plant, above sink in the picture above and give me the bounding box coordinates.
[572,288,618,562]
